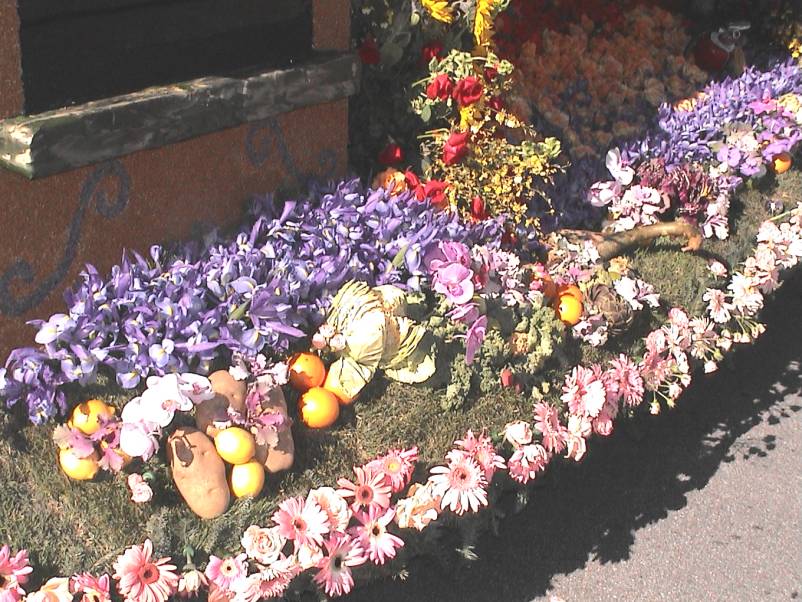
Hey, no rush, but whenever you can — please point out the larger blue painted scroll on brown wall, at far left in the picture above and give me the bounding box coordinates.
[0,161,131,316]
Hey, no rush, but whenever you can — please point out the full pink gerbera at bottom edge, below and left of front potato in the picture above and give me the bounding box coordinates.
[114,539,178,602]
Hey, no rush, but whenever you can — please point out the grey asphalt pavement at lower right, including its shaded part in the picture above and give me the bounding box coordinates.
[349,273,802,602]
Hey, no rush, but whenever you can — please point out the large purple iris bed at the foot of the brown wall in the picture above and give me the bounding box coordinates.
[0,180,502,424]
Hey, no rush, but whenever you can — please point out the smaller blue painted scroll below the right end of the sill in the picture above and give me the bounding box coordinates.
[245,117,337,188]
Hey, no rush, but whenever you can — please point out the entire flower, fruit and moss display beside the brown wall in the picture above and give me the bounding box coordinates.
[0,0,802,601]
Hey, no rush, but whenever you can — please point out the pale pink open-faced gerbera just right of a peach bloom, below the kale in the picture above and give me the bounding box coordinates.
[429,450,487,514]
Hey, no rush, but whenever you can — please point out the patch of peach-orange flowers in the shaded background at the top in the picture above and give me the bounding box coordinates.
[517,6,707,159]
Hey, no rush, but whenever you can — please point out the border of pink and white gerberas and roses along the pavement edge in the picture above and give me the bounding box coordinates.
[6,196,802,601]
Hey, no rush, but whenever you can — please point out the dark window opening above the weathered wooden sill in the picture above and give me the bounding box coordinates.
[18,0,312,114]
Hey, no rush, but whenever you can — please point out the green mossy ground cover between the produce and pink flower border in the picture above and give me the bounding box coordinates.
[0,170,802,581]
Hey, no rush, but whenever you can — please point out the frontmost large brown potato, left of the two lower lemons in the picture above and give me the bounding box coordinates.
[167,427,231,518]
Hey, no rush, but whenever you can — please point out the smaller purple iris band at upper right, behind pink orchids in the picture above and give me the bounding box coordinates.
[622,59,802,166]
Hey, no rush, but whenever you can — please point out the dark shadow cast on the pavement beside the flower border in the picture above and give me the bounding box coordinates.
[349,271,802,602]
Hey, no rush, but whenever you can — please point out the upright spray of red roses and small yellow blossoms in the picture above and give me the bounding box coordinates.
[412,50,561,224]
